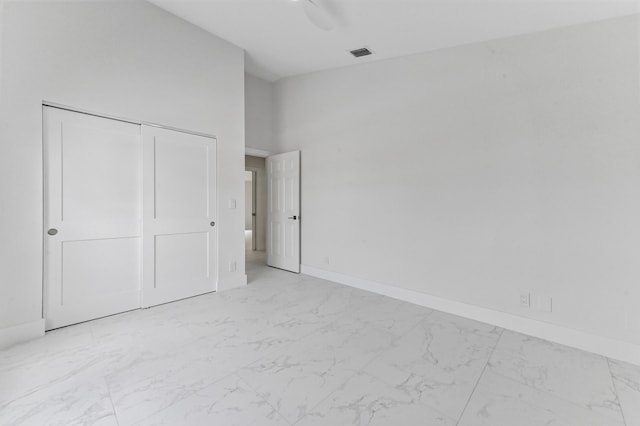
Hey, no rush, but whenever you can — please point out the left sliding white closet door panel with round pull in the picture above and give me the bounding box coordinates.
[43,107,142,330]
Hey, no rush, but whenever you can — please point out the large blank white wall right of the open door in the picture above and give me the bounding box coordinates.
[274,17,640,350]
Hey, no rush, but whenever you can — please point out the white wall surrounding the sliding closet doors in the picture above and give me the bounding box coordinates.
[0,1,246,344]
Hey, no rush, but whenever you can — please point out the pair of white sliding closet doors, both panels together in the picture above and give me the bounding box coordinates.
[43,107,217,330]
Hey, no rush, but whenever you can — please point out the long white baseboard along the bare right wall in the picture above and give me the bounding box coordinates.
[301,265,640,365]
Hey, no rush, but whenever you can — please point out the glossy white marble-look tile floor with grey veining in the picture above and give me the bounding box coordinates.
[0,251,640,426]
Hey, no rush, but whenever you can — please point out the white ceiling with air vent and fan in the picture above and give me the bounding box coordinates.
[151,0,638,81]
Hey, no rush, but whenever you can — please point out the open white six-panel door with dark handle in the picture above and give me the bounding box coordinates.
[267,151,300,272]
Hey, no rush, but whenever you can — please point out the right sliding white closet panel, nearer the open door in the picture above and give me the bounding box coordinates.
[142,125,217,307]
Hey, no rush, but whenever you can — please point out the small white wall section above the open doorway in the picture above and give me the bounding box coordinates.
[245,74,273,151]
